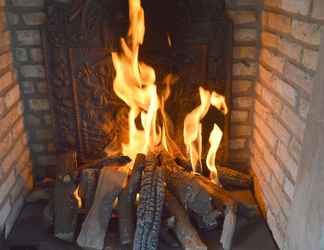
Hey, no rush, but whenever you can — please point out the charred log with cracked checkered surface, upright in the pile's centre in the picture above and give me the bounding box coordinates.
[133,155,165,250]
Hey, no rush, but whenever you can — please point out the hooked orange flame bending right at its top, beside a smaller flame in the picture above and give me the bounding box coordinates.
[183,87,228,171]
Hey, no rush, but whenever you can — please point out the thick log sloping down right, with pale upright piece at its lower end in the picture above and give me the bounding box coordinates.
[161,153,238,250]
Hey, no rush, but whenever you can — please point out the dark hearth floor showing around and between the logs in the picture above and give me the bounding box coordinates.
[8,203,278,250]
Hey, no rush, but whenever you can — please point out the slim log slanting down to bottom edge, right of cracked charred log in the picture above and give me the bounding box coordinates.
[165,189,207,250]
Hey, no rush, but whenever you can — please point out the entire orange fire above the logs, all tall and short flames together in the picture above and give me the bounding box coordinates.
[112,0,228,184]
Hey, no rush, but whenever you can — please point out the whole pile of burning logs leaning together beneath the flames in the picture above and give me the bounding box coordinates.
[54,152,256,250]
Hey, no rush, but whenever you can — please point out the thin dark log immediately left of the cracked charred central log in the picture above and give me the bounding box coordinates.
[118,154,145,250]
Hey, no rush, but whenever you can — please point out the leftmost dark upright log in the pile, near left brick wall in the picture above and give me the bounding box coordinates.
[54,152,77,241]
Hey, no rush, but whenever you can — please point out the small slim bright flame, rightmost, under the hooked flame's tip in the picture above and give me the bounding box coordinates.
[206,124,223,184]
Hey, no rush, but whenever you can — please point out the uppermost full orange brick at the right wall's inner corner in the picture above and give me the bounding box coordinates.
[262,12,292,33]
